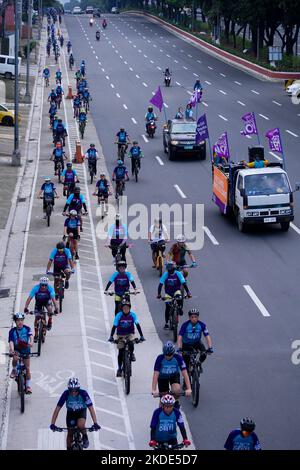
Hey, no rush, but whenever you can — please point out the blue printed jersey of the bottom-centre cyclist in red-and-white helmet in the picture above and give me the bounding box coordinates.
[150,408,184,442]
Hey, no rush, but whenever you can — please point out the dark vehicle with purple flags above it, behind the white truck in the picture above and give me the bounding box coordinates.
[163,119,206,160]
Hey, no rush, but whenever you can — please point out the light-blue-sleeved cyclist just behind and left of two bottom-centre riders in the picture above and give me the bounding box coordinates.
[108,299,145,377]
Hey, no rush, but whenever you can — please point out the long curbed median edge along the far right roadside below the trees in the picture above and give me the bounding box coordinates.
[124,10,300,81]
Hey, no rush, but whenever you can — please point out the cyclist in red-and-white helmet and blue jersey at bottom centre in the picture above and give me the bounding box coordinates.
[149,394,191,447]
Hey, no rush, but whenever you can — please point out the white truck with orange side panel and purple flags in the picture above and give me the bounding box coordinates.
[212,163,300,232]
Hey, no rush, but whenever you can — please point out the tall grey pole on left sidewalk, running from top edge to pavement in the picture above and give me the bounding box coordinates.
[11,0,22,166]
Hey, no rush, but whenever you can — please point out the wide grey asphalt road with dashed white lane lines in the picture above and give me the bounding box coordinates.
[66,15,300,449]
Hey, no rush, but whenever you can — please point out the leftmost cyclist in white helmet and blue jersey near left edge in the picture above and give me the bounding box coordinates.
[8,312,33,394]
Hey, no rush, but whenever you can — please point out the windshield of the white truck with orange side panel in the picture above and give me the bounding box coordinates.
[245,173,290,196]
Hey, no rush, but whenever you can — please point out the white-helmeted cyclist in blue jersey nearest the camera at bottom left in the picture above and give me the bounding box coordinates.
[50,377,100,450]
